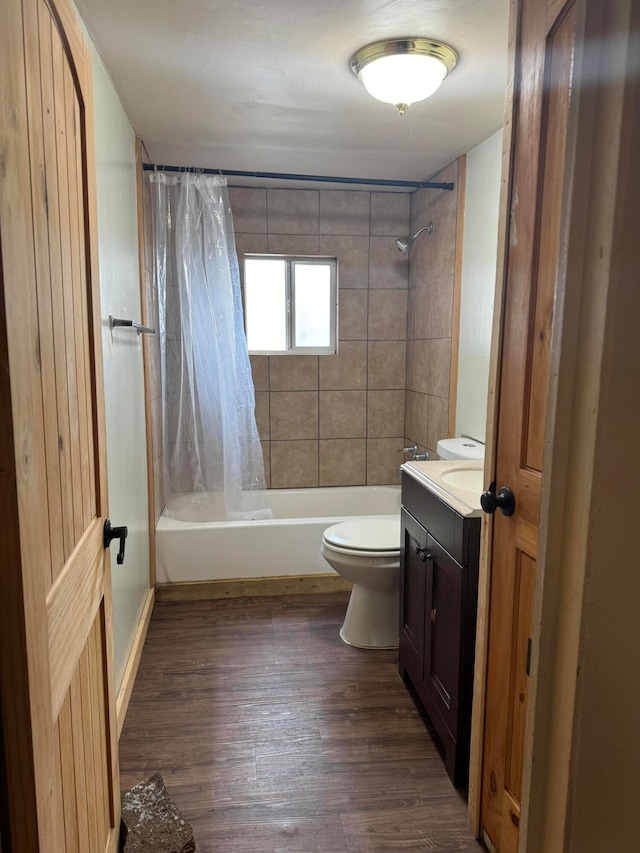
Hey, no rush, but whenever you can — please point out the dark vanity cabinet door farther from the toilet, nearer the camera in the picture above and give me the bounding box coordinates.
[424,536,464,739]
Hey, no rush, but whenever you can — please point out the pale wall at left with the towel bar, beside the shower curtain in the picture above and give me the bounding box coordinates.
[93,43,149,688]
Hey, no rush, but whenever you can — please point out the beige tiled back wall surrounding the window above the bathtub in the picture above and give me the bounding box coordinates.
[230,187,411,488]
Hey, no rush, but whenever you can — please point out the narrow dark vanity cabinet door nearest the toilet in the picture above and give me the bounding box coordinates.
[400,510,427,687]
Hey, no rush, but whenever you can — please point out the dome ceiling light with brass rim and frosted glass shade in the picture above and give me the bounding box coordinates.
[351,38,458,115]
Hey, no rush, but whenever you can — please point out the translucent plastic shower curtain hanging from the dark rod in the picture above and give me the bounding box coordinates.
[147,172,271,521]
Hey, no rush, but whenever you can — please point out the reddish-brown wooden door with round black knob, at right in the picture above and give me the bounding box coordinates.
[481,0,576,853]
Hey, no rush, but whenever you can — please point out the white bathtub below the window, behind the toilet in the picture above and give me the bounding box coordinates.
[156,486,400,583]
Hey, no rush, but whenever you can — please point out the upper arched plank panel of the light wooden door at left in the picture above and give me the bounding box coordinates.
[24,0,96,581]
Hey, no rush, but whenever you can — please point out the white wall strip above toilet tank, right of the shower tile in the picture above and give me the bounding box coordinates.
[456,130,502,441]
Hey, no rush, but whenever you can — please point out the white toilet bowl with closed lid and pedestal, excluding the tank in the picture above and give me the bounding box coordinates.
[320,515,400,649]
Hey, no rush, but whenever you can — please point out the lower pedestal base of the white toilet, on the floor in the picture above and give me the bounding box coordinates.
[340,583,399,649]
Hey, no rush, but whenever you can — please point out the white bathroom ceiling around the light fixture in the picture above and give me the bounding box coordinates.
[78,0,509,188]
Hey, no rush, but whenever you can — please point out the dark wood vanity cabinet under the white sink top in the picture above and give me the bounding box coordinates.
[398,471,480,787]
